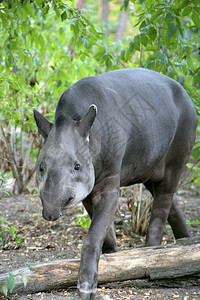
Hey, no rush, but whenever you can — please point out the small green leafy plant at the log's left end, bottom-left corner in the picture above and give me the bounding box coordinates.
[0,272,28,296]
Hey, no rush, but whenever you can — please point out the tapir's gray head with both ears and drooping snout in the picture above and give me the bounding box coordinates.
[33,105,96,221]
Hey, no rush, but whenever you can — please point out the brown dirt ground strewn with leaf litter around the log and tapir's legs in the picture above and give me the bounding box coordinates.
[0,188,200,300]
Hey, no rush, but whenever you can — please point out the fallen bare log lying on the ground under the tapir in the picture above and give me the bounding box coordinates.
[0,239,200,294]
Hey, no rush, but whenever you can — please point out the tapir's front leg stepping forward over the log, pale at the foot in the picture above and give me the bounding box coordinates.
[78,178,119,300]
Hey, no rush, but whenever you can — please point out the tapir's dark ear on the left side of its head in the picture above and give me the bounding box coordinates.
[33,108,53,140]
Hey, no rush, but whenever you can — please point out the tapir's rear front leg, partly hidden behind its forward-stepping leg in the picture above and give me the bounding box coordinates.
[83,197,117,253]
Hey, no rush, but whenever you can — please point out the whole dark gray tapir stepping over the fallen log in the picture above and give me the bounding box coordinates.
[34,68,197,299]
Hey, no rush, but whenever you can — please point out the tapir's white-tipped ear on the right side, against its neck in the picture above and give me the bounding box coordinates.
[77,104,97,137]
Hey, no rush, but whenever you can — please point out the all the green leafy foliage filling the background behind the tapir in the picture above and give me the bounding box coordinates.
[0,0,200,193]
